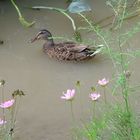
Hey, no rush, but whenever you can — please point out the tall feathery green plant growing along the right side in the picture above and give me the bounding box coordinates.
[61,0,140,140]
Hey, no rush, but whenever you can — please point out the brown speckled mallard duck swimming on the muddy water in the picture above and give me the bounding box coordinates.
[31,29,99,61]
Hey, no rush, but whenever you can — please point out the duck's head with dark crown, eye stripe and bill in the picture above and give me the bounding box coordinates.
[31,29,53,43]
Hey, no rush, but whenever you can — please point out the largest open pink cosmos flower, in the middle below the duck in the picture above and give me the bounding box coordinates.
[61,89,75,101]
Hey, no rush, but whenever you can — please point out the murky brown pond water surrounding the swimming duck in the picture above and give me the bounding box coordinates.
[0,0,140,140]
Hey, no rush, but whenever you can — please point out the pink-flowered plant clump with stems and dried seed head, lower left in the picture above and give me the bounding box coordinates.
[0,80,25,140]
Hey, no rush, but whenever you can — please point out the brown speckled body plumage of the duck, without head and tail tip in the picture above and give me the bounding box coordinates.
[43,42,93,61]
